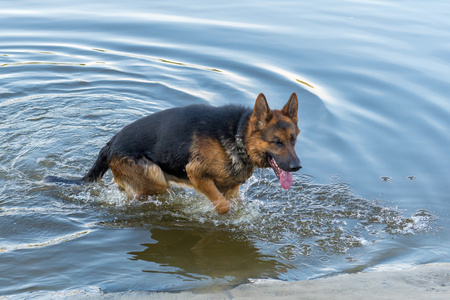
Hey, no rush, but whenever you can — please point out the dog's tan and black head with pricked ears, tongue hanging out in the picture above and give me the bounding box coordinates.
[246,93,302,189]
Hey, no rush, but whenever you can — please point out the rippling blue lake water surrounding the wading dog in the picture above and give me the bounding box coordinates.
[0,0,450,298]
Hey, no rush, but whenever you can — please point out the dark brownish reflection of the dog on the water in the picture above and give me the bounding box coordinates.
[128,228,284,284]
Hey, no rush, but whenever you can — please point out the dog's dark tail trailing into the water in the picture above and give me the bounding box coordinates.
[44,143,110,185]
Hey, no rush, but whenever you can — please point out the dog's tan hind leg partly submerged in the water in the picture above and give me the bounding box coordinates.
[109,158,169,198]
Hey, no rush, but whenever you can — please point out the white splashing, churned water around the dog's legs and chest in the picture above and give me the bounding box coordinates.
[61,170,436,260]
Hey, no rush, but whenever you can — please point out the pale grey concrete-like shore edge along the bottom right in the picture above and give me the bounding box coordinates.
[59,264,450,300]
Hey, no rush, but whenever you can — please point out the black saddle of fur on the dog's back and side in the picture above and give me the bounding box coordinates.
[108,105,251,179]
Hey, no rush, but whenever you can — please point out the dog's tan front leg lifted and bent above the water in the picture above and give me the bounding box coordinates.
[189,176,230,215]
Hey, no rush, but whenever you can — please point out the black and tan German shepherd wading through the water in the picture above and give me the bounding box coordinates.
[44,93,301,214]
